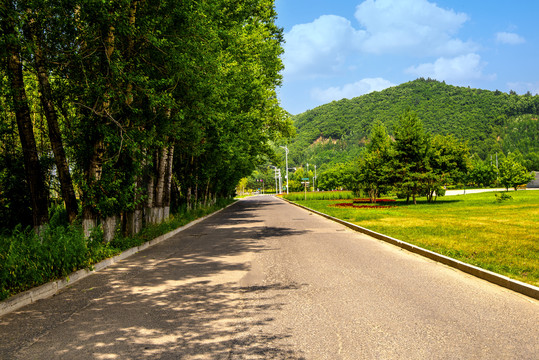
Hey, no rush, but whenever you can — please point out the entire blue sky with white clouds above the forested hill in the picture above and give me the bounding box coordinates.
[275,0,539,114]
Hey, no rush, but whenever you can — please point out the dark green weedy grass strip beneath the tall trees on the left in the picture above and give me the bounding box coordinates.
[0,200,233,300]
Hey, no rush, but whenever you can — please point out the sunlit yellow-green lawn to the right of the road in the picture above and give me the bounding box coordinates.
[284,191,539,286]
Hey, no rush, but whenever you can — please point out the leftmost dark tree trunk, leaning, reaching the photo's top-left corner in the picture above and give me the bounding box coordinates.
[0,1,48,231]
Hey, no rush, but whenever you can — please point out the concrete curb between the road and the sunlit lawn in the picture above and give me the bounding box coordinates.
[283,199,539,300]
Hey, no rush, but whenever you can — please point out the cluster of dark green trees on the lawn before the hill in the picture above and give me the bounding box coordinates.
[319,110,533,204]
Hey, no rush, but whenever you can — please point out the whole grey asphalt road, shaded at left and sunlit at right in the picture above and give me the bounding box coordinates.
[0,196,539,359]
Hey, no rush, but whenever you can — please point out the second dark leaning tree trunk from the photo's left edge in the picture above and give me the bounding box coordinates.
[27,22,78,223]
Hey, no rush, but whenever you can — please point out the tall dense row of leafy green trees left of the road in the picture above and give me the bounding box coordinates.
[0,0,293,234]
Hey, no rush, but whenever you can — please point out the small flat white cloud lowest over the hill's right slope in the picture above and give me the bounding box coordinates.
[406,53,495,84]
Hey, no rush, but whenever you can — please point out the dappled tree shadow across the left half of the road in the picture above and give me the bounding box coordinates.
[0,197,305,359]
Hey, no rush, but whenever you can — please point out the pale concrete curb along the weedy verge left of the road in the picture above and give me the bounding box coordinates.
[0,202,236,317]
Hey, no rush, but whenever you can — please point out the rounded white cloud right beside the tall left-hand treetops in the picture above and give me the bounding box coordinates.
[283,15,364,76]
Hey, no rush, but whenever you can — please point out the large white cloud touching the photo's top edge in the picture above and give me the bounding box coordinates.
[355,0,477,56]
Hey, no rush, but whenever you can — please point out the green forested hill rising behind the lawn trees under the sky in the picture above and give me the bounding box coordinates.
[289,78,539,169]
